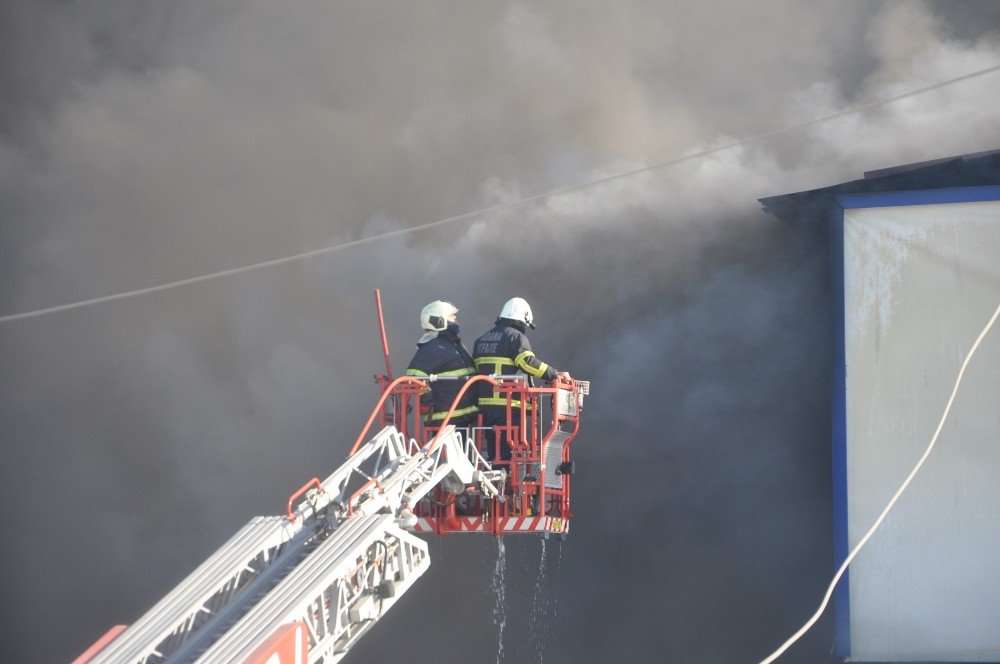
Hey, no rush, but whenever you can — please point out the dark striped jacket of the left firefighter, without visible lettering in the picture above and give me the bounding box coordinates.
[406,323,479,422]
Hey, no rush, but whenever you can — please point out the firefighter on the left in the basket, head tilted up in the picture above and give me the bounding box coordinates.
[406,300,479,427]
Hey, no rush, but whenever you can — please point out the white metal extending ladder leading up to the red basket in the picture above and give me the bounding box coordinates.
[84,426,504,664]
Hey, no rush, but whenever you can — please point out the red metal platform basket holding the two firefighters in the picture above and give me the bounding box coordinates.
[366,291,590,537]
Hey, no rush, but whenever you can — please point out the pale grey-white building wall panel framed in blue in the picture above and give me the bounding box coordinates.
[843,195,1000,662]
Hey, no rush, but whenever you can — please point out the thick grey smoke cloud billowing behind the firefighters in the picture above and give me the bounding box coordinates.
[0,0,1000,662]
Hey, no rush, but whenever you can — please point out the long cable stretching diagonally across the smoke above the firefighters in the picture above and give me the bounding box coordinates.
[0,65,1000,323]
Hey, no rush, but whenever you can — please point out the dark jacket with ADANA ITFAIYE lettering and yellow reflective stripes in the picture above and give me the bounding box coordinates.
[472,318,558,407]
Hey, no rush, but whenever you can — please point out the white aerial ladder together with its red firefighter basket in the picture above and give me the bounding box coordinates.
[73,291,589,664]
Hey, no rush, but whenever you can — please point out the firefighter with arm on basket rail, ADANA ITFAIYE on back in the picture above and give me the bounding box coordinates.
[472,297,570,461]
